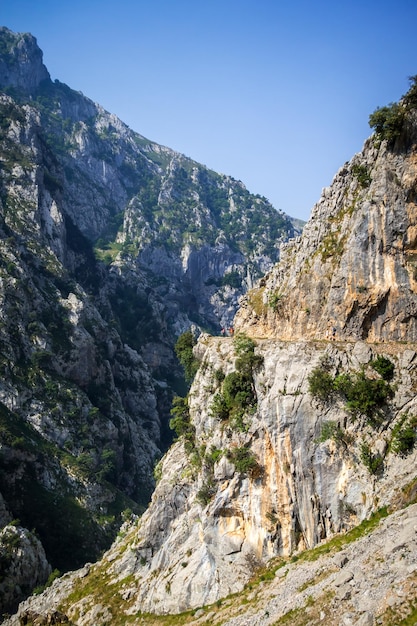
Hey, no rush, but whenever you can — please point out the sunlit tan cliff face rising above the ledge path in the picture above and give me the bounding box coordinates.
[236,111,417,341]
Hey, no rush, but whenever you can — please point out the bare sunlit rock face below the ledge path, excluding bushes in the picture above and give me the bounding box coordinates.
[98,337,417,613]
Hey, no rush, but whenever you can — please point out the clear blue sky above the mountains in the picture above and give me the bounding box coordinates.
[0,0,417,219]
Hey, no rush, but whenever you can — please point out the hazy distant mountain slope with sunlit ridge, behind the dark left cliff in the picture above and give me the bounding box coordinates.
[0,28,297,329]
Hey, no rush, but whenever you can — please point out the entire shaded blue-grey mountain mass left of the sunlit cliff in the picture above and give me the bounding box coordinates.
[0,27,297,613]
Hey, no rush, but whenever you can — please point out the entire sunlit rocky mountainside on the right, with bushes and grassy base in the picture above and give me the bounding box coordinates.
[6,78,417,626]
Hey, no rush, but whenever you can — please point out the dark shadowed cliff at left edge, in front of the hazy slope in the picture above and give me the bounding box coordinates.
[0,86,163,570]
